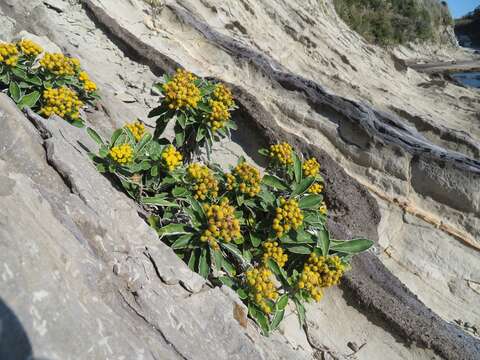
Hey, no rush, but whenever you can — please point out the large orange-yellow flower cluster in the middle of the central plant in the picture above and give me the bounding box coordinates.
[200,198,241,250]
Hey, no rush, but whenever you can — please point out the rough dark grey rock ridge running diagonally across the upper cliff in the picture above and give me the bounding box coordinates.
[167,3,480,173]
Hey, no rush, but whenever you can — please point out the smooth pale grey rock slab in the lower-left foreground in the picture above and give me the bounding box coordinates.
[0,94,310,360]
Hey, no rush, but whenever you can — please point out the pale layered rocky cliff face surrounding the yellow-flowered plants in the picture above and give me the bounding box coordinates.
[0,0,480,359]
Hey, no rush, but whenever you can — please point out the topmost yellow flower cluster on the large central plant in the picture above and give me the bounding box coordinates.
[163,69,201,110]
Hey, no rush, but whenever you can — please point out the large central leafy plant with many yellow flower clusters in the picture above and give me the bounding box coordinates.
[87,70,372,335]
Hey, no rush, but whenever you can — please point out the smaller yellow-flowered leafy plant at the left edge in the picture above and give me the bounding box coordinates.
[0,39,99,126]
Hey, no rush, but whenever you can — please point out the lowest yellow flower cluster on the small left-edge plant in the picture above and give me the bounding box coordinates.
[40,86,83,120]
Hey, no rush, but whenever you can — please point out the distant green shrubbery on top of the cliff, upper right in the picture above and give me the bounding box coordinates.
[333,0,453,45]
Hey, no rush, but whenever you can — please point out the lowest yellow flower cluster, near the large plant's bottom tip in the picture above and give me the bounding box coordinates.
[245,266,278,314]
